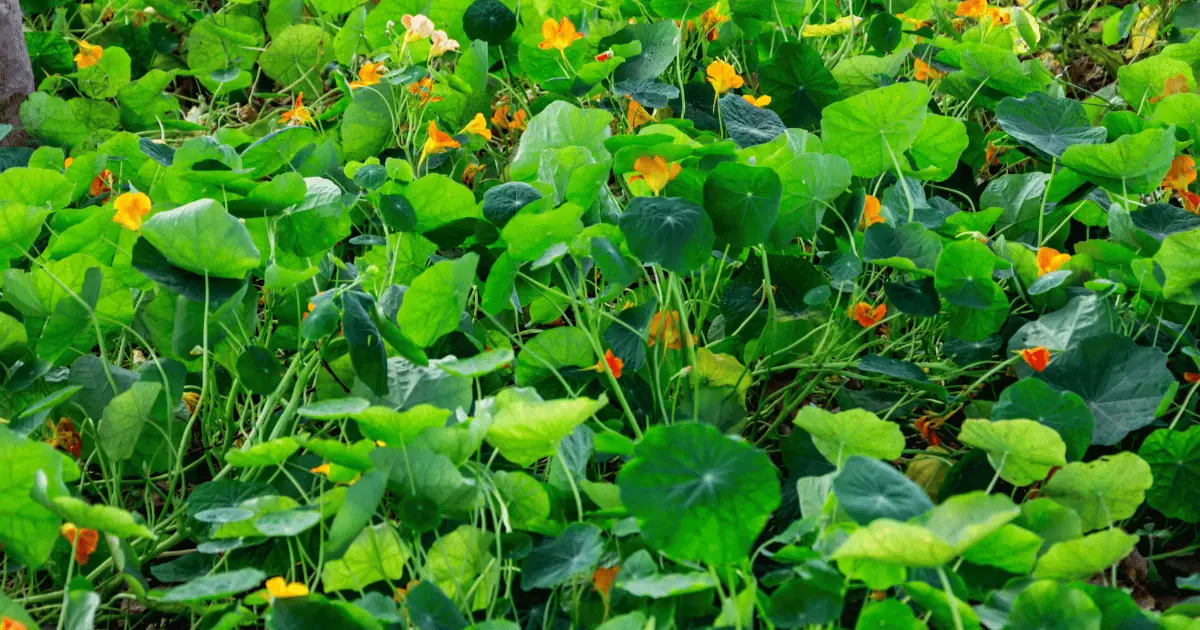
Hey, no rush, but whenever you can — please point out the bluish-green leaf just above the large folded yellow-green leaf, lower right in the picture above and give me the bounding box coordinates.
[833,455,934,524]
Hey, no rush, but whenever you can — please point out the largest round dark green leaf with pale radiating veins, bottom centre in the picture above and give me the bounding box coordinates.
[617,422,780,565]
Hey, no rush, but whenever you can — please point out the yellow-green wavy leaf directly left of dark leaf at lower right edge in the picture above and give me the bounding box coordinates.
[1042,452,1153,532]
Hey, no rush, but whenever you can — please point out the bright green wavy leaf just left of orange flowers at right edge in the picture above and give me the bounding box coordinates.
[1062,128,1175,194]
